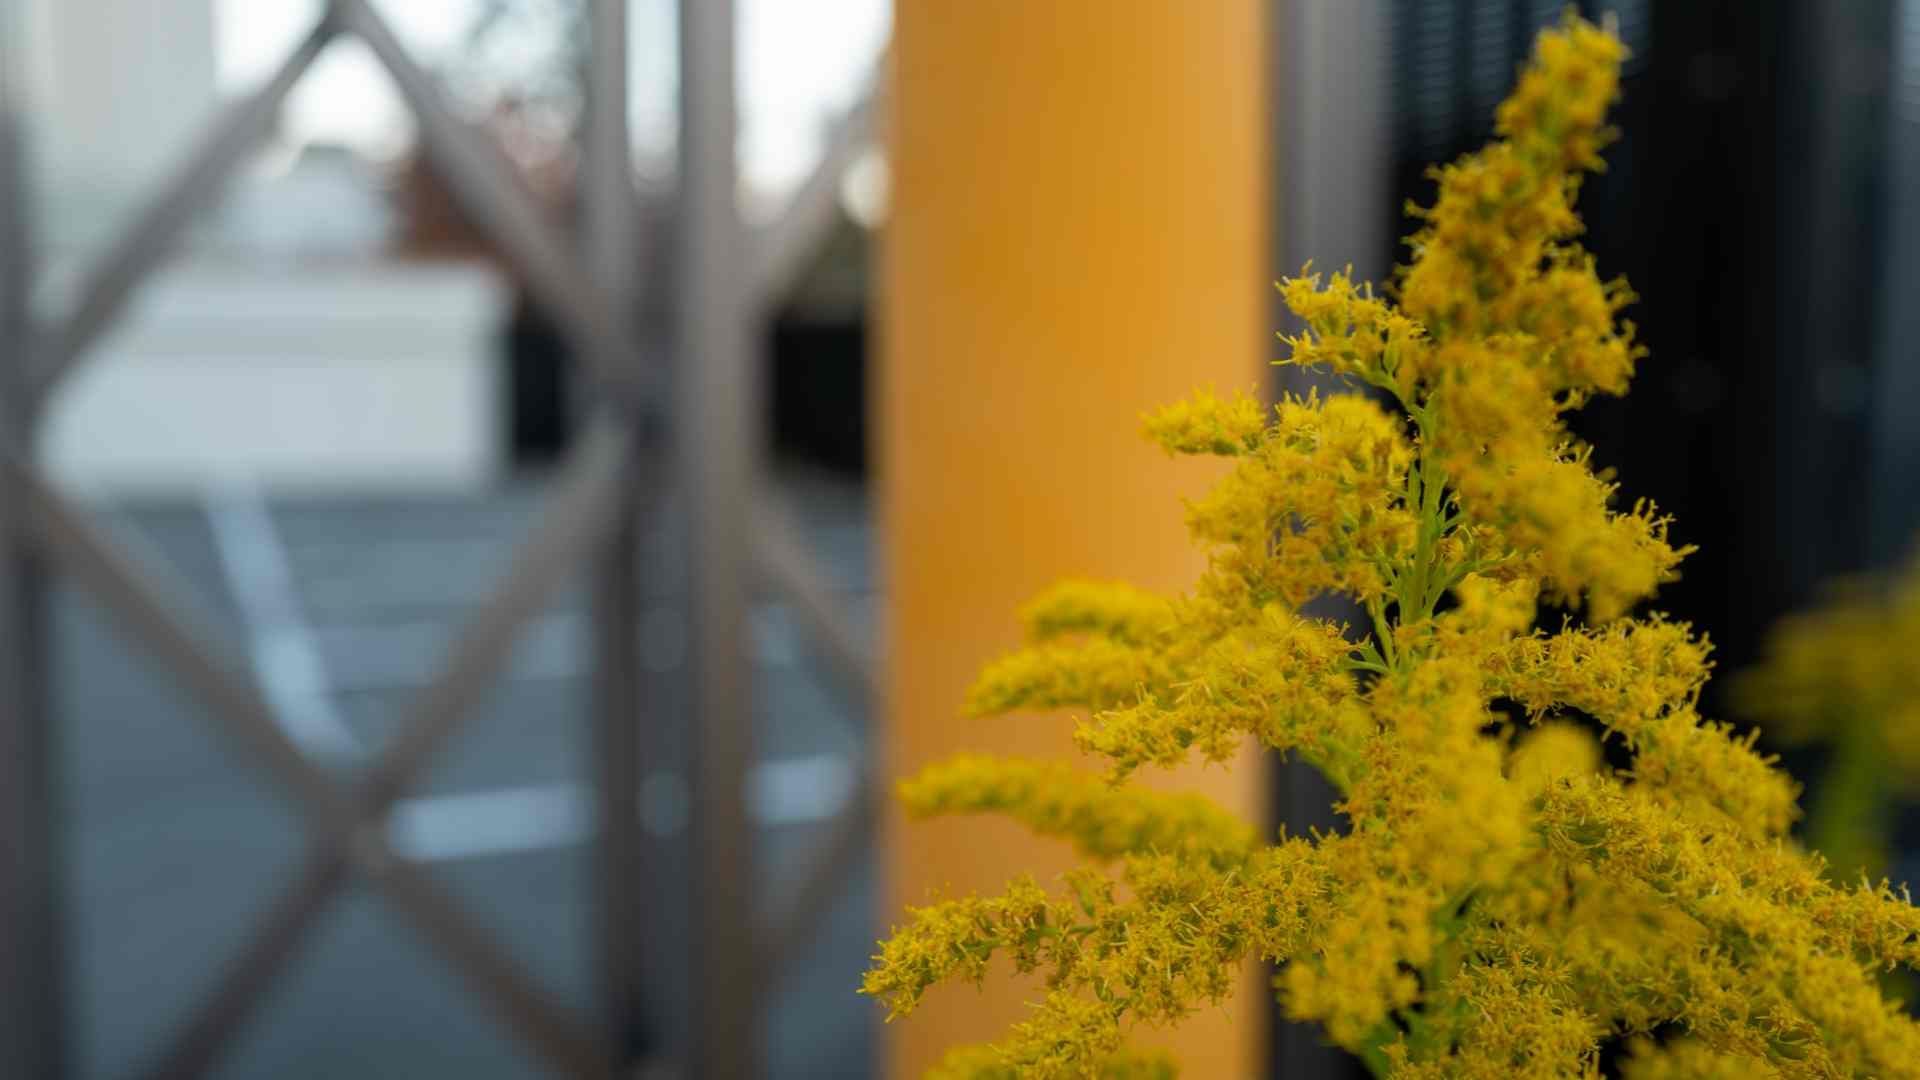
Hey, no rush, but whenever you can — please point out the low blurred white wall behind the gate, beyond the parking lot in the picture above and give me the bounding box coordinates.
[38,261,509,494]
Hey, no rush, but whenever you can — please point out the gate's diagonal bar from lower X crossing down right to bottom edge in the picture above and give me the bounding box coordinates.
[361,849,612,1080]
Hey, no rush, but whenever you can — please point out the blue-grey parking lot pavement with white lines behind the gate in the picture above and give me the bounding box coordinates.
[50,468,879,1080]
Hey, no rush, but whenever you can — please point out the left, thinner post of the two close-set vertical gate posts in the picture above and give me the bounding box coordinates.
[582,0,651,1076]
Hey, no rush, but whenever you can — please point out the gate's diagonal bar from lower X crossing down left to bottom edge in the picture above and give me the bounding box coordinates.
[144,849,348,1080]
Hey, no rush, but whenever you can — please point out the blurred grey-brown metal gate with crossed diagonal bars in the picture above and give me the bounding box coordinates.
[0,0,877,1078]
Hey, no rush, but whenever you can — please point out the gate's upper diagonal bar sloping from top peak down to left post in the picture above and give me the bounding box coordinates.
[29,19,334,402]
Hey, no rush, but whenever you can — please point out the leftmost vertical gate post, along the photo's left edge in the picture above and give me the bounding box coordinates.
[0,10,67,1078]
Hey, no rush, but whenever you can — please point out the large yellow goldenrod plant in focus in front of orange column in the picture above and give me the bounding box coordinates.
[864,17,1920,1078]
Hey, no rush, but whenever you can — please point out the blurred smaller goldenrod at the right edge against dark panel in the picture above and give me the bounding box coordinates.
[1734,553,1920,880]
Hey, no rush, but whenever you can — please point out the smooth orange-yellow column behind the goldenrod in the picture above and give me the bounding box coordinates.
[876,0,1275,1076]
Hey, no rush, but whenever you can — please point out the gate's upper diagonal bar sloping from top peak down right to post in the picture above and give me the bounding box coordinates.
[332,0,624,375]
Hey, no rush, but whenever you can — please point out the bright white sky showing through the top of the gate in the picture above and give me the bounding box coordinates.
[211,0,891,194]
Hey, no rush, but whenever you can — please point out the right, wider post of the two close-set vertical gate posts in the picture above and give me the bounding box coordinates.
[674,0,758,1080]
